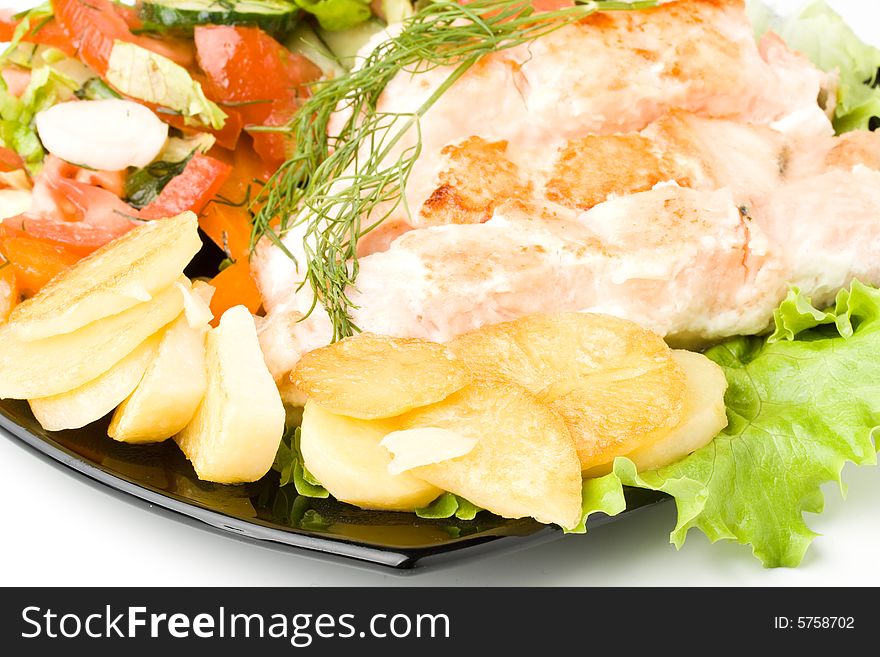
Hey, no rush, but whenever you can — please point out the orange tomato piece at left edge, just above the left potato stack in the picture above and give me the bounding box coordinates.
[0,231,82,297]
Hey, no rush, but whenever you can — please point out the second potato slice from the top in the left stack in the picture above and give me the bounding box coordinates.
[0,279,189,399]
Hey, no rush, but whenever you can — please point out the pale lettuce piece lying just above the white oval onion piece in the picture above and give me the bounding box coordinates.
[106,41,227,130]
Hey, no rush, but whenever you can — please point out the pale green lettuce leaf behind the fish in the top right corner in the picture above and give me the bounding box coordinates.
[749,0,880,133]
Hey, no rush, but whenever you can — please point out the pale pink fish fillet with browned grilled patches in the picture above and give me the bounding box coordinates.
[253,0,880,378]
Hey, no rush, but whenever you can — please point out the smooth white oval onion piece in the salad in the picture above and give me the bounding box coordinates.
[37,99,168,171]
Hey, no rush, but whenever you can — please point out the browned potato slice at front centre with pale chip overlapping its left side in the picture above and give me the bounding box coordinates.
[399,381,581,528]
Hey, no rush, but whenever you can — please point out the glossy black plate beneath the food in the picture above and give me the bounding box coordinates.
[0,401,667,572]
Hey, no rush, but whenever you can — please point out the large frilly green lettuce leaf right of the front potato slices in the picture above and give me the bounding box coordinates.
[604,282,880,567]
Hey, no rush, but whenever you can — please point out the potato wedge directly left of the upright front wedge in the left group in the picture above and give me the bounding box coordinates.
[107,314,208,443]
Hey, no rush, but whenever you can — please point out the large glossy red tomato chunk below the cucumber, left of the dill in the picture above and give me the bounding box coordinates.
[195,25,321,126]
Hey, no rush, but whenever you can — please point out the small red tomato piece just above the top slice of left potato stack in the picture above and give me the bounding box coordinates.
[140,154,232,219]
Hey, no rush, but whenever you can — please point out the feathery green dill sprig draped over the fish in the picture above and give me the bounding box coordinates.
[251,0,657,340]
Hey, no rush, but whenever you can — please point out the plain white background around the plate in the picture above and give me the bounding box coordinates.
[0,0,880,586]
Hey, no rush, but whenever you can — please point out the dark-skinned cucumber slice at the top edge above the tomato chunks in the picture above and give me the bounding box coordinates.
[140,0,300,34]
